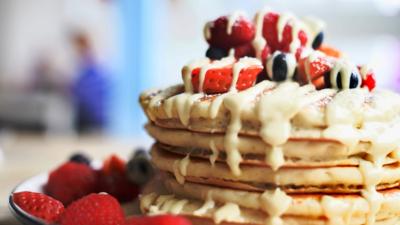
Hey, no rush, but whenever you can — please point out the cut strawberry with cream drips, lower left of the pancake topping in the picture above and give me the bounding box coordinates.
[191,57,263,94]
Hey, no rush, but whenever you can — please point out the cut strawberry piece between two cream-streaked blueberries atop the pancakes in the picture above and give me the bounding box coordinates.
[297,55,333,89]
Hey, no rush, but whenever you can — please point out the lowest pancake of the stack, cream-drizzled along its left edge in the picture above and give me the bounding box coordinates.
[141,193,400,225]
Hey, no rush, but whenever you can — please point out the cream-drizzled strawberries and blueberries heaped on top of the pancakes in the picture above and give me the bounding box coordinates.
[187,11,375,94]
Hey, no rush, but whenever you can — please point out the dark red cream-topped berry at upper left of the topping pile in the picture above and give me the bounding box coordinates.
[205,16,255,50]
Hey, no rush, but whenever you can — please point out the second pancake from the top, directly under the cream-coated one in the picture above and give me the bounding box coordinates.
[146,124,398,165]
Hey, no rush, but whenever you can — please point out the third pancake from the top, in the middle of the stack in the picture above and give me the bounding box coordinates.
[151,145,400,193]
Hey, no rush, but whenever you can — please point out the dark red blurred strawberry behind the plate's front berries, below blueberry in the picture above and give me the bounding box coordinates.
[45,162,97,205]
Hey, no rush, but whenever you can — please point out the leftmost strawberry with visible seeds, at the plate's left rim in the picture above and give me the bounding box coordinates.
[12,191,64,223]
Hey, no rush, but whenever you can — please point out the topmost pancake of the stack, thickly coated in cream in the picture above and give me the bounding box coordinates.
[140,81,400,145]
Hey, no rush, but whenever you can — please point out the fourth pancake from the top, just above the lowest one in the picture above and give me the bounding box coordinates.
[164,178,400,219]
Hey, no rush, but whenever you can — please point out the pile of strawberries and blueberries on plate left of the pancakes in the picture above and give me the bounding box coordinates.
[12,151,190,225]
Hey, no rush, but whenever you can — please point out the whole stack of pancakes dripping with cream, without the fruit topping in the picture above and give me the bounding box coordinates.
[140,8,400,225]
